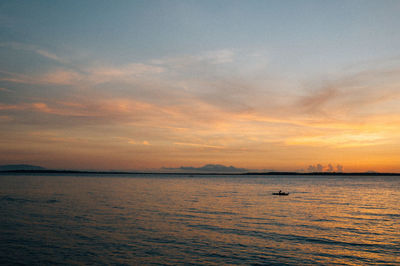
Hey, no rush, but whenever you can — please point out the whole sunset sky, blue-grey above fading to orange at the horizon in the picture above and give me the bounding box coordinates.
[0,0,400,172]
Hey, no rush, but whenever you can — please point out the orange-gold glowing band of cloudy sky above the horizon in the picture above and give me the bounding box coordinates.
[0,47,400,171]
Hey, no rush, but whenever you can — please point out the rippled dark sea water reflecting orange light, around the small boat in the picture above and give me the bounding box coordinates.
[0,175,400,265]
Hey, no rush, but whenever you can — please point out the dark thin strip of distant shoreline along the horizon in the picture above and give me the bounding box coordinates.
[0,170,400,176]
